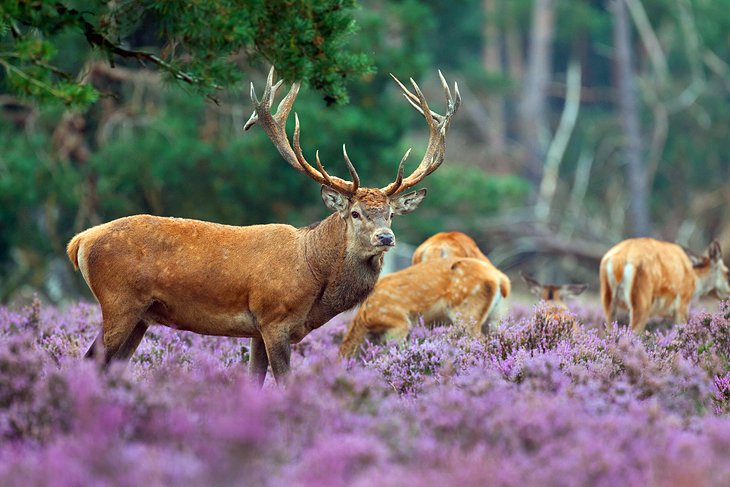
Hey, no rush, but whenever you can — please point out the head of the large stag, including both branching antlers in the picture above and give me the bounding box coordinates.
[244,68,461,260]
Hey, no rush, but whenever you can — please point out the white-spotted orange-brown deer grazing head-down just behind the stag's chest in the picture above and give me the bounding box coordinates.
[340,258,509,357]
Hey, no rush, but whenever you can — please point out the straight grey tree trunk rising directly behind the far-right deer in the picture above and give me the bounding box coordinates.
[610,0,651,237]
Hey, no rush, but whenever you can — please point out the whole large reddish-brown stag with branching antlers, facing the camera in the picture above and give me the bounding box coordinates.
[68,68,461,383]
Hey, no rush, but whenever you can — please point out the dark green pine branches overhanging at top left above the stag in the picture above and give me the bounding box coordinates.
[0,0,372,106]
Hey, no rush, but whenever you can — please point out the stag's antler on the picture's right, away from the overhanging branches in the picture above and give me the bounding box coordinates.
[381,71,461,196]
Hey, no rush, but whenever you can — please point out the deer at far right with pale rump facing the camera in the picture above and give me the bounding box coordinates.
[600,238,730,333]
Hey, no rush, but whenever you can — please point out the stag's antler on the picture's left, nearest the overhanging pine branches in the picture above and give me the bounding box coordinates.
[243,67,360,196]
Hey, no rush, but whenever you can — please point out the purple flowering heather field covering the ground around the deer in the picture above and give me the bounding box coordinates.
[0,302,730,487]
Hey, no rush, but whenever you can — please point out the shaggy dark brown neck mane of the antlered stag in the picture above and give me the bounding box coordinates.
[304,213,383,314]
